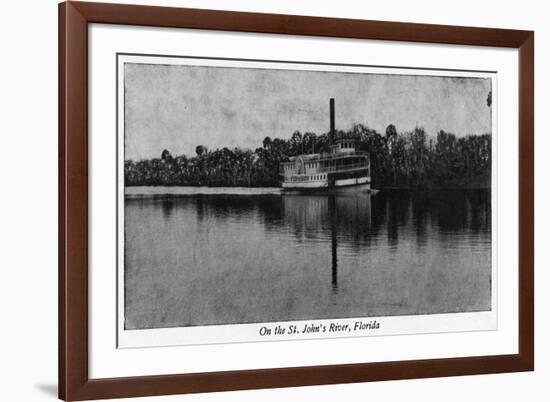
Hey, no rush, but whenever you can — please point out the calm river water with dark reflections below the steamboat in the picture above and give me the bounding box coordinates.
[124,190,491,329]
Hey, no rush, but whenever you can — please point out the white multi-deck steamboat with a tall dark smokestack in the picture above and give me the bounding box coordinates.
[279,98,371,192]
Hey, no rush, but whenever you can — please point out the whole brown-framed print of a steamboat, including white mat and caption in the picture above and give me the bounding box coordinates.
[59,2,534,400]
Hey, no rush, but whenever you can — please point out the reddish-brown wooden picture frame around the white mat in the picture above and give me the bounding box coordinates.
[59,1,534,400]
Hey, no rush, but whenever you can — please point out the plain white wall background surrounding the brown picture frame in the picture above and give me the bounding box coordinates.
[0,0,550,402]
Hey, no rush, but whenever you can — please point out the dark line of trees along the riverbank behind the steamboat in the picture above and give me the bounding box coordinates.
[124,124,491,188]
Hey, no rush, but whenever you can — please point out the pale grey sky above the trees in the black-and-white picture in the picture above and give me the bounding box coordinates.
[124,63,491,160]
